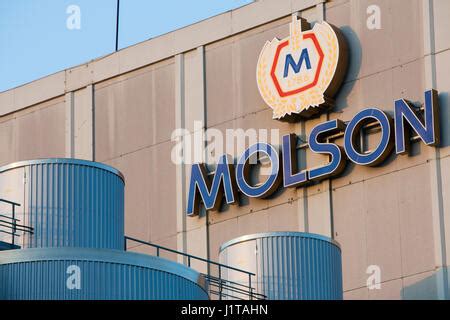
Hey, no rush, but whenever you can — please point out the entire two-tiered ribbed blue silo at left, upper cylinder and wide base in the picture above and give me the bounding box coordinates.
[0,159,209,300]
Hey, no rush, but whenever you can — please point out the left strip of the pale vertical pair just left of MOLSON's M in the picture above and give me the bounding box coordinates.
[175,53,187,263]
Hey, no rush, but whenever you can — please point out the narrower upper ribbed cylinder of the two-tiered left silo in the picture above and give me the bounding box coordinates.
[0,159,124,249]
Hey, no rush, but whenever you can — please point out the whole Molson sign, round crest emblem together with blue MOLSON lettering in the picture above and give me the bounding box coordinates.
[187,18,440,216]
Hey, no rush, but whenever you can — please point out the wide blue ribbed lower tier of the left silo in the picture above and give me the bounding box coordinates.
[0,248,208,300]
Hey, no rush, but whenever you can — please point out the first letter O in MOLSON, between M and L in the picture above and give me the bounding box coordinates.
[236,142,281,198]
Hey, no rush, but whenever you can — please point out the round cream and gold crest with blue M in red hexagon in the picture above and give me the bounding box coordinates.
[256,17,348,121]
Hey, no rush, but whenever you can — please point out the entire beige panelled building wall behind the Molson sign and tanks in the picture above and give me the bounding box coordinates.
[0,0,450,299]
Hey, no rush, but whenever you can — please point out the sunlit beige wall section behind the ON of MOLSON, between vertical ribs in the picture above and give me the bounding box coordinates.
[327,1,435,298]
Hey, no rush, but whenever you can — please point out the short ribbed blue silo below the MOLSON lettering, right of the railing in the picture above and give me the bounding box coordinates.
[220,232,343,300]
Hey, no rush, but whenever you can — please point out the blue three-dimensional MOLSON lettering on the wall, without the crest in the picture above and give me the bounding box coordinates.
[187,90,440,216]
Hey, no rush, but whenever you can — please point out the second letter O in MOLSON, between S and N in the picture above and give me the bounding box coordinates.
[344,108,393,166]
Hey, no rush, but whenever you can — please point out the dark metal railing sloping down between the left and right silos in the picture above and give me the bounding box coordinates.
[124,236,266,300]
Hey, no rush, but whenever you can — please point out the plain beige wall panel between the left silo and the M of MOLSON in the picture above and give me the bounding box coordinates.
[95,59,177,248]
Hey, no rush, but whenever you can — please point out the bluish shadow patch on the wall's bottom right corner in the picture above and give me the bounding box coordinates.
[401,267,450,300]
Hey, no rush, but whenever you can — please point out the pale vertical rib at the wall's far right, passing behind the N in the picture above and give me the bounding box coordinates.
[422,0,449,299]
